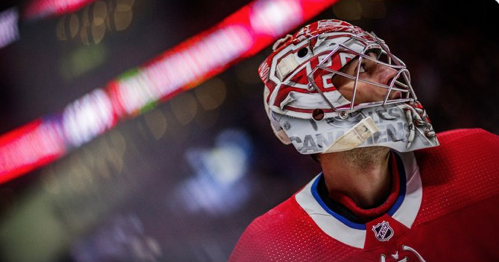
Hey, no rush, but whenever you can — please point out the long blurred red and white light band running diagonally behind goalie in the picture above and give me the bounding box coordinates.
[0,0,338,183]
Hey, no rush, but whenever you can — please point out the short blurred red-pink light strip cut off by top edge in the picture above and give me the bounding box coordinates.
[23,0,95,20]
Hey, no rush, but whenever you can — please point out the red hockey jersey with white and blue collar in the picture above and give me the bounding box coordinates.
[230,129,499,261]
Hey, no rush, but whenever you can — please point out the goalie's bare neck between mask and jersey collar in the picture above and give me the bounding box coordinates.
[320,147,391,209]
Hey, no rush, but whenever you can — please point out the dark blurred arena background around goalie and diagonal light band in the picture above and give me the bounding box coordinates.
[0,0,499,262]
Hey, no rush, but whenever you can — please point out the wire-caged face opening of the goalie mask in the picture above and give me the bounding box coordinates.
[307,36,416,111]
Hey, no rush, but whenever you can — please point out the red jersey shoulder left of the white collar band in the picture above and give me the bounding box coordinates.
[229,190,353,262]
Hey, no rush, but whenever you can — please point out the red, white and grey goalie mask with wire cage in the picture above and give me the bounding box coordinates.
[258,20,438,154]
